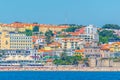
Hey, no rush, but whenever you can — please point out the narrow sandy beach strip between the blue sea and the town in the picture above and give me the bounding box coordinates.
[0,67,120,72]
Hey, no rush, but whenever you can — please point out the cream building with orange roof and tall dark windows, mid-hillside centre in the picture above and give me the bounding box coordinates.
[62,38,84,49]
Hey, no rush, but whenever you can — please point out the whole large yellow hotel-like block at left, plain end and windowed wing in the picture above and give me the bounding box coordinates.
[0,30,33,50]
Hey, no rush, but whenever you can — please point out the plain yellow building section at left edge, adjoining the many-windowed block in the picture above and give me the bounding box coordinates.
[0,31,10,49]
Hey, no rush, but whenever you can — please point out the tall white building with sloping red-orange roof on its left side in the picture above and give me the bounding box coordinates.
[68,25,99,42]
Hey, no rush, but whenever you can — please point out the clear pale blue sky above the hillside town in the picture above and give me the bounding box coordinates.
[0,0,120,26]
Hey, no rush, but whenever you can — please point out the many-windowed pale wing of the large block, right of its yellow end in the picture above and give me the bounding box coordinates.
[9,32,33,49]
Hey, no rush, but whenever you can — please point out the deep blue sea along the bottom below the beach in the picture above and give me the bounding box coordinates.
[0,71,120,80]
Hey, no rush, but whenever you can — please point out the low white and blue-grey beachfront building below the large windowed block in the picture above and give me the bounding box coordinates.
[0,49,34,66]
